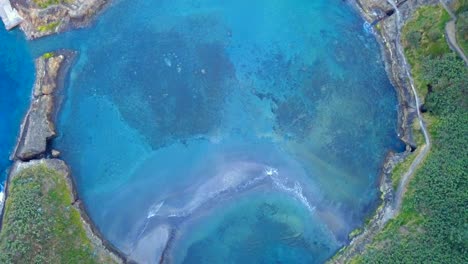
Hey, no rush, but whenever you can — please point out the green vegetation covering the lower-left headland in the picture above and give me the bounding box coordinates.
[0,165,116,264]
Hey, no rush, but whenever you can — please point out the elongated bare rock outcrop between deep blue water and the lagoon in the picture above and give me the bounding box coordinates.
[13,51,73,161]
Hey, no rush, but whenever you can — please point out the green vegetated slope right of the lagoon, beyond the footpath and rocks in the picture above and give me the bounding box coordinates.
[353,4,468,263]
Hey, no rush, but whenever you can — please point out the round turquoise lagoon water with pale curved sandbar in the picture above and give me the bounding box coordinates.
[2,0,402,263]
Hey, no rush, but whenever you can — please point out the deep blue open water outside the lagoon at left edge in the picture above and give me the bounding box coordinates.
[0,29,34,182]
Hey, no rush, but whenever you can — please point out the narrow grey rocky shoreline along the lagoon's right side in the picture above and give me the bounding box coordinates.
[329,0,438,263]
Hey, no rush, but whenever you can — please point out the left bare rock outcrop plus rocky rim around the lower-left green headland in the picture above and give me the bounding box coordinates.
[0,50,126,263]
